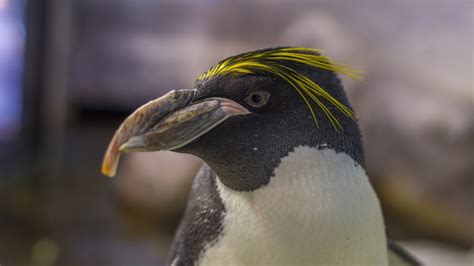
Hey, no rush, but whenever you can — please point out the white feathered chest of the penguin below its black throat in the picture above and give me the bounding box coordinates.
[199,147,387,266]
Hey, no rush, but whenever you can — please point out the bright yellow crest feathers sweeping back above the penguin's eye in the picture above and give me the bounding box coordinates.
[198,47,362,130]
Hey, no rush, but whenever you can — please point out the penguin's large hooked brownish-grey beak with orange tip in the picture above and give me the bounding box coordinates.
[102,90,250,177]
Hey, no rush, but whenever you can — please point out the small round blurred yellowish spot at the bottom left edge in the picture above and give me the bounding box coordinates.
[31,238,60,266]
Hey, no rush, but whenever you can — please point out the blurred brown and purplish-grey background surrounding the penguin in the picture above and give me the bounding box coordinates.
[0,0,474,266]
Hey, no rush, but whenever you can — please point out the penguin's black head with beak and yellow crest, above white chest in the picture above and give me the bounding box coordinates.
[102,47,364,191]
